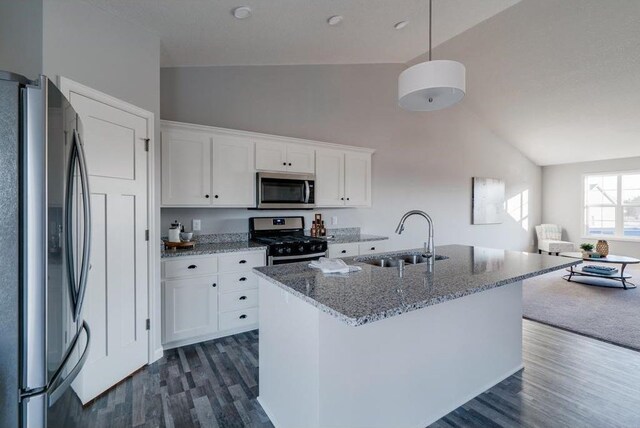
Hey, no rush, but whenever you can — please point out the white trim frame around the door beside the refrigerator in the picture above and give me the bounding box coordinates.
[58,76,164,364]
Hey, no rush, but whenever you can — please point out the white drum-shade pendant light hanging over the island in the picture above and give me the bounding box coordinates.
[398,0,466,111]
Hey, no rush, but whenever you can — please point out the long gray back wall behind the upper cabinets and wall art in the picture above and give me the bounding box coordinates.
[160,64,541,250]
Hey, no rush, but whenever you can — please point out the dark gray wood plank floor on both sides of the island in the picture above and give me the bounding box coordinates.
[53,320,640,428]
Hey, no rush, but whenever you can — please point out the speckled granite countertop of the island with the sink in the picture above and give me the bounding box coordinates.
[254,245,581,326]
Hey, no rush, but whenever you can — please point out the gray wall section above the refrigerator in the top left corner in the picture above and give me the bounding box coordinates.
[0,0,42,79]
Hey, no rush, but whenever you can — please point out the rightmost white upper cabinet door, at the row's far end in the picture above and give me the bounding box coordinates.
[344,152,371,207]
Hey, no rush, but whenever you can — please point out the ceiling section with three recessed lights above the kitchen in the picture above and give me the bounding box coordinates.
[82,0,520,67]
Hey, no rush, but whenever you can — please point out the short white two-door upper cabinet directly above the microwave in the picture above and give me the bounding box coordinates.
[256,140,315,174]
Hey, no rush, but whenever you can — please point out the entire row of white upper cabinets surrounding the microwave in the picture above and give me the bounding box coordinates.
[161,121,374,208]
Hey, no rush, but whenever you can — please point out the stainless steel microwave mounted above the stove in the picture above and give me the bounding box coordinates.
[256,172,315,210]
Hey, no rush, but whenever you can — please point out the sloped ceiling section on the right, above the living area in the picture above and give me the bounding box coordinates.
[435,0,640,167]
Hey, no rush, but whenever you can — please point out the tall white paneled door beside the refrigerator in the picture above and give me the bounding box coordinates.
[70,92,150,404]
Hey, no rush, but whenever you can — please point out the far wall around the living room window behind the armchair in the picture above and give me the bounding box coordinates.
[542,157,640,258]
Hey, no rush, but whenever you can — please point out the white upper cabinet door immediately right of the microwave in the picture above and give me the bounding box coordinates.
[315,149,344,207]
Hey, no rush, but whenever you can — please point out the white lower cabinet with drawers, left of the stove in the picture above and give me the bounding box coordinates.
[162,251,266,349]
